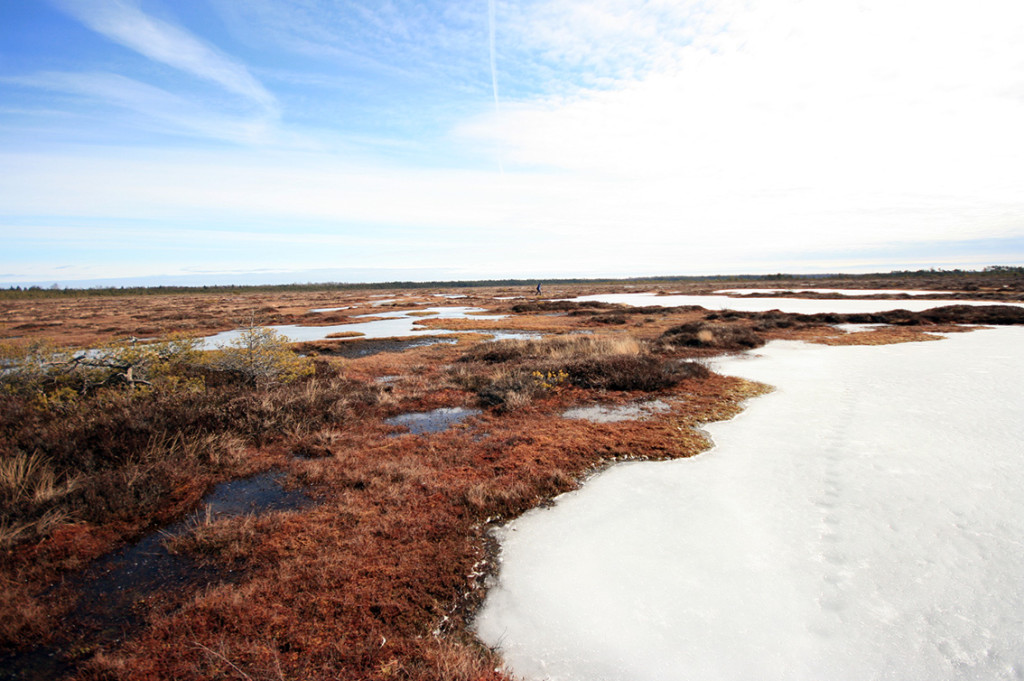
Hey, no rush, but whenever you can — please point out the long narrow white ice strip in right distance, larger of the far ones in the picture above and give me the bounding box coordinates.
[571,293,1024,314]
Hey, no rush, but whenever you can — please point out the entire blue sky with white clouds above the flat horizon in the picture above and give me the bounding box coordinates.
[0,0,1024,286]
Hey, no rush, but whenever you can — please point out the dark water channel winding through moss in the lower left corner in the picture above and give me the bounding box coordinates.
[0,471,310,681]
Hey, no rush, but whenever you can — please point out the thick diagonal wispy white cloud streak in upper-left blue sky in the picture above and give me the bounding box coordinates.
[54,0,278,112]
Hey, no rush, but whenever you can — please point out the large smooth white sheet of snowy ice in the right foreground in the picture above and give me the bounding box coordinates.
[475,328,1024,681]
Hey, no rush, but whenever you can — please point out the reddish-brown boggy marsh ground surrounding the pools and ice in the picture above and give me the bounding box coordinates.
[0,272,1019,679]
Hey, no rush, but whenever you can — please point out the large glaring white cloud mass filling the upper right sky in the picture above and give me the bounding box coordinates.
[457,0,1024,251]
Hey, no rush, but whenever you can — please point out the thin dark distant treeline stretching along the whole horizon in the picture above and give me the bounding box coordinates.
[0,265,1024,300]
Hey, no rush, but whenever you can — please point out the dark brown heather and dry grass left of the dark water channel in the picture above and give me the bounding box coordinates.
[0,356,361,645]
